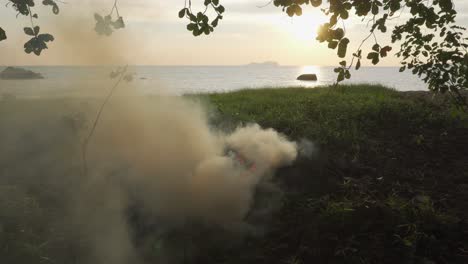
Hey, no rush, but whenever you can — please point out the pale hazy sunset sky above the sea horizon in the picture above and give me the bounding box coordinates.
[0,0,468,66]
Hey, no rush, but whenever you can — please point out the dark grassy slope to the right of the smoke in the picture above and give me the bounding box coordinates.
[203,85,468,263]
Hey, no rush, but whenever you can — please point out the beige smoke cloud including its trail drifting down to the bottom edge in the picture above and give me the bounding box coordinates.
[62,90,298,263]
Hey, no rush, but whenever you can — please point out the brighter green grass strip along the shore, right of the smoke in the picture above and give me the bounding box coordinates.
[209,85,464,142]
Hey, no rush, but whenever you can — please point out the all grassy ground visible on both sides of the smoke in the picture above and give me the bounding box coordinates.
[0,85,468,264]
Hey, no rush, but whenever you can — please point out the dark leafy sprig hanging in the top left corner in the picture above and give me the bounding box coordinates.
[0,0,60,56]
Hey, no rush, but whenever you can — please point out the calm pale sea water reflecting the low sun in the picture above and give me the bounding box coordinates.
[0,66,426,98]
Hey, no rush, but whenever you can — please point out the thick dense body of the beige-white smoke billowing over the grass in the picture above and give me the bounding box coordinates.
[90,94,297,224]
